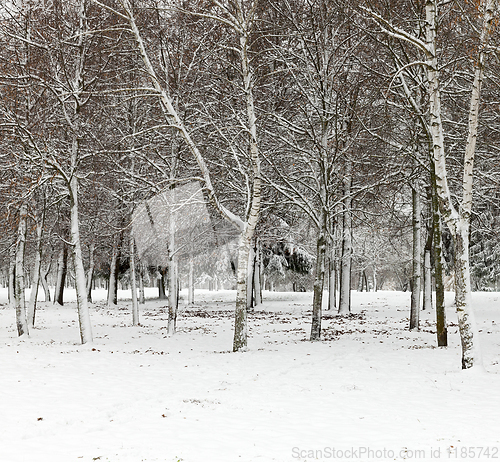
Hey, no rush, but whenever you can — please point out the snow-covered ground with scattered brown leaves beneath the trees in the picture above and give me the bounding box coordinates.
[0,291,500,462]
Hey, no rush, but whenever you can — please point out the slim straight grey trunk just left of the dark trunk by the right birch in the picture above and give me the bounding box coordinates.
[410,184,422,330]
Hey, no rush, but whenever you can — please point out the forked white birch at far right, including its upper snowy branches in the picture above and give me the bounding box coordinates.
[364,0,497,369]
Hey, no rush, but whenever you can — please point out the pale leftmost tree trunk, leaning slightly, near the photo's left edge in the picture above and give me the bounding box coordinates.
[14,203,29,337]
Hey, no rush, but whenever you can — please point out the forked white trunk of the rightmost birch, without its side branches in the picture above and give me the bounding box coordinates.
[426,0,497,369]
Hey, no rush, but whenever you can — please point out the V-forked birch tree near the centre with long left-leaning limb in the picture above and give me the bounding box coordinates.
[95,0,261,351]
